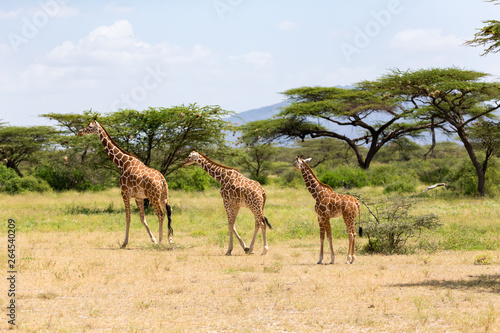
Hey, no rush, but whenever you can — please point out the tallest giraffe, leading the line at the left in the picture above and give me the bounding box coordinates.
[78,120,173,249]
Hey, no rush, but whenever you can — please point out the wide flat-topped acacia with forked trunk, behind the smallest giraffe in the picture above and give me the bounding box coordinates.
[240,85,439,169]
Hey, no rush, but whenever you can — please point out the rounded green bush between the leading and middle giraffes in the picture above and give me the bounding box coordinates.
[167,166,220,192]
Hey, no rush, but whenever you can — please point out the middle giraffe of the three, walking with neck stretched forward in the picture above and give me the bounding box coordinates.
[182,149,272,256]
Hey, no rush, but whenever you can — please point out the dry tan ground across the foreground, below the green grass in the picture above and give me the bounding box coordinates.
[0,230,500,332]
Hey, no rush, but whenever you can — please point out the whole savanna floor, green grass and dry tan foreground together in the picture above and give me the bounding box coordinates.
[0,186,500,332]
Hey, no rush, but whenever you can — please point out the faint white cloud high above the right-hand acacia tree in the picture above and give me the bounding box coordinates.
[389,29,464,52]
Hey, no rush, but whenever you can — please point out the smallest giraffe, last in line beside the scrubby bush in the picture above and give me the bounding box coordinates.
[295,156,362,264]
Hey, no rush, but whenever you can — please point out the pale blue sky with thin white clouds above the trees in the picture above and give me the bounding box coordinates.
[0,0,500,126]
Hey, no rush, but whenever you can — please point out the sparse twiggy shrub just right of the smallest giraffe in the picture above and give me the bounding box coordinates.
[363,197,441,253]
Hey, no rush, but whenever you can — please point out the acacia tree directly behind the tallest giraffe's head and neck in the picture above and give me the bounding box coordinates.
[44,104,231,175]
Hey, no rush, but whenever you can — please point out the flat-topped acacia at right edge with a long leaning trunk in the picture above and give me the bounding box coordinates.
[373,68,500,195]
